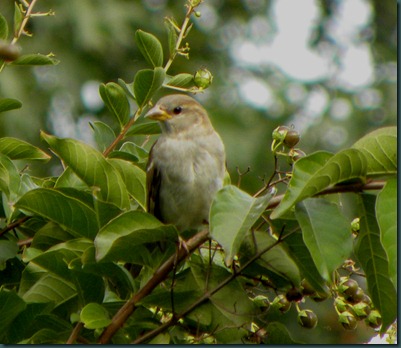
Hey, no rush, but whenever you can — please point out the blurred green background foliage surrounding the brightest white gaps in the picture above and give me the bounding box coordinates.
[0,0,397,192]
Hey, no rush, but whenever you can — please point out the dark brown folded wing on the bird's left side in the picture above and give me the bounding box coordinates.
[146,141,161,220]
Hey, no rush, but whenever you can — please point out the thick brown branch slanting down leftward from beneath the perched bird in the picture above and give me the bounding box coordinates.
[98,230,209,344]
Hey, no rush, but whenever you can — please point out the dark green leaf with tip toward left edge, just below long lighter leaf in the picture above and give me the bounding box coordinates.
[15,188,98,239]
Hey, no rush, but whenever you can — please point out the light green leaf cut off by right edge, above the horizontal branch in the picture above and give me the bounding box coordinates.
[353,127,397,176]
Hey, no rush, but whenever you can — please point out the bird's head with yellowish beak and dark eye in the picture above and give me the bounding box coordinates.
[145,94,213,137]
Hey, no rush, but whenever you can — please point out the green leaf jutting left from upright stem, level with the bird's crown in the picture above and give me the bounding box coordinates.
[99,82,129,128]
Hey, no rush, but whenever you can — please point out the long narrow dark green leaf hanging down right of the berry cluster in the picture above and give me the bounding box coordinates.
[355,194,397,334]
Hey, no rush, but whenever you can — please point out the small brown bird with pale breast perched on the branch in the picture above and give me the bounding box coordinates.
[145,94,225,231]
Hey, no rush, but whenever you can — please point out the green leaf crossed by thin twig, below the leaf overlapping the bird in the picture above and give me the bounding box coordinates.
[239,231,301,290]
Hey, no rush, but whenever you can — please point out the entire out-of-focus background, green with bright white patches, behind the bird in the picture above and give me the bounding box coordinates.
[0,0,397,343]
